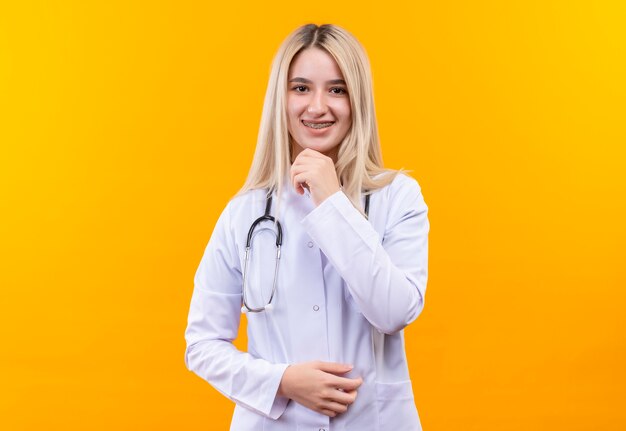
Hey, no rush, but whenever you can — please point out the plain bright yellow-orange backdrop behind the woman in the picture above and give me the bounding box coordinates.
[0,0,626,431]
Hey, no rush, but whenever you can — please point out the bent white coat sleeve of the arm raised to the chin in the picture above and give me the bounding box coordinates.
[302,174,430,334]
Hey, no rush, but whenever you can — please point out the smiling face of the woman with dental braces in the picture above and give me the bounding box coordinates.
[287,48,352,161]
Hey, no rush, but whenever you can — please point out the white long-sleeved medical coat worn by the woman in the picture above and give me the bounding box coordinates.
[185,174,429,431]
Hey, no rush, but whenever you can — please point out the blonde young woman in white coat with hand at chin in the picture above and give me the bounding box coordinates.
[185,24,429,431]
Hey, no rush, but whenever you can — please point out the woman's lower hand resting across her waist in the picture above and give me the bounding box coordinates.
[278,361,363,417]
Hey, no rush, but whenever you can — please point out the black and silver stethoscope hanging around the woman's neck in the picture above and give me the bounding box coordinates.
[241,190,370,313]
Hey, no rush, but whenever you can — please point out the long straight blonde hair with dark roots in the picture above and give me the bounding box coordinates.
[237,24,400,212]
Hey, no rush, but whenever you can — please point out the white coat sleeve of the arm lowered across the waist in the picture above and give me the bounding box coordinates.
[185,206,288,419]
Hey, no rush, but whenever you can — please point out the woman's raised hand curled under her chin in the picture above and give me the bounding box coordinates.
[291,148,341,206]
